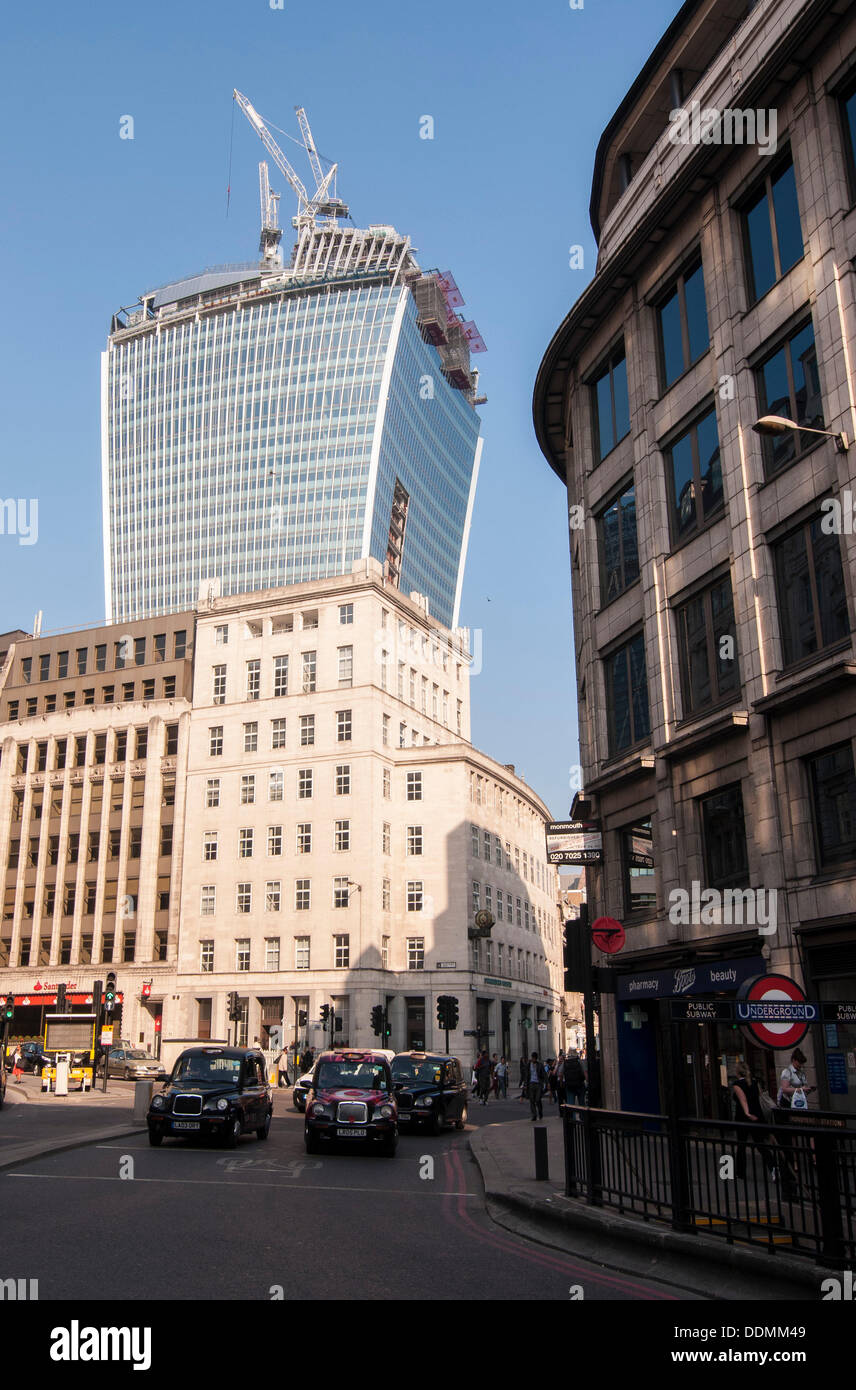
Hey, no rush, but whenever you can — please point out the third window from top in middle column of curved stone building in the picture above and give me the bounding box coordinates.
[675,575,741,719]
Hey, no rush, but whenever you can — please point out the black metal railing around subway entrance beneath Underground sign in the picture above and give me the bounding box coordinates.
[561,1105,856,1268]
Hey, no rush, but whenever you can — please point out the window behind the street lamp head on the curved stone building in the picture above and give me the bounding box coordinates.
[756,321,825,478]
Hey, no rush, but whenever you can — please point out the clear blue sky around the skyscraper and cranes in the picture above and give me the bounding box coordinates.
[0,0,678,817]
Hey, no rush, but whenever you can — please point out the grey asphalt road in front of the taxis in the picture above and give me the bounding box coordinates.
[0,1093,693,1302]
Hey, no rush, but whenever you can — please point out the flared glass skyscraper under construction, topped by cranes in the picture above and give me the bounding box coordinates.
[101,228,479,626]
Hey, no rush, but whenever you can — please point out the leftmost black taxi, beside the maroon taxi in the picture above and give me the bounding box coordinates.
[146,1047,274,1148]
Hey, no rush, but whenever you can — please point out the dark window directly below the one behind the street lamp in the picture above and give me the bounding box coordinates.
[773,517,850,666]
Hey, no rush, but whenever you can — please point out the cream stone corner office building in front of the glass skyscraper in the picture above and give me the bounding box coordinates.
[168,559,561,1058]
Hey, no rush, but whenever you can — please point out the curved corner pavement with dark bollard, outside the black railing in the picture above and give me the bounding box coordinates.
[468,1101,818,1300]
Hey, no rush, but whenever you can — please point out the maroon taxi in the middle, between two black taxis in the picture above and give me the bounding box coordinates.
[304,1048,399,1158]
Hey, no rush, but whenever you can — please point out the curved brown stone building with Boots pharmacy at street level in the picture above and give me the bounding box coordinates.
[534,0,856,1115]
